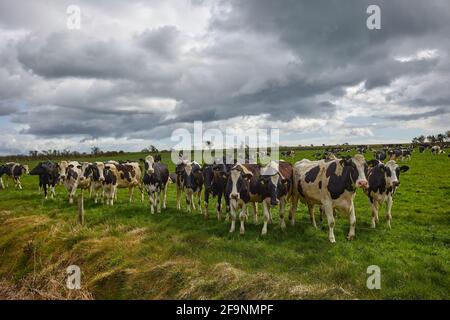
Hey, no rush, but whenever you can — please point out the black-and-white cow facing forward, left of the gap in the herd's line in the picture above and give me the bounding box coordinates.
[141,155,169,214]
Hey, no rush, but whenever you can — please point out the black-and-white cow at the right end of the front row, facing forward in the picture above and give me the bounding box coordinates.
[365,160,409,228]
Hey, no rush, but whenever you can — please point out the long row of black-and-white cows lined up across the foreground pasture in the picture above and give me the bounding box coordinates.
[0,148,428,243]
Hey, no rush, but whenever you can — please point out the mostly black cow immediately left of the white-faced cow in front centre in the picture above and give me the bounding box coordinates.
[202,161,231,221]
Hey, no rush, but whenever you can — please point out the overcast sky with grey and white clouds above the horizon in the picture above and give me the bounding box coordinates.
[0,0,450,154]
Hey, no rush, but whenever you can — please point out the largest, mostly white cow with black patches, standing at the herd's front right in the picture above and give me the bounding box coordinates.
[289,154,368,243]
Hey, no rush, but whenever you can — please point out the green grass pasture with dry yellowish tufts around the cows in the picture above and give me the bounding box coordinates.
[0,151,450,299]
